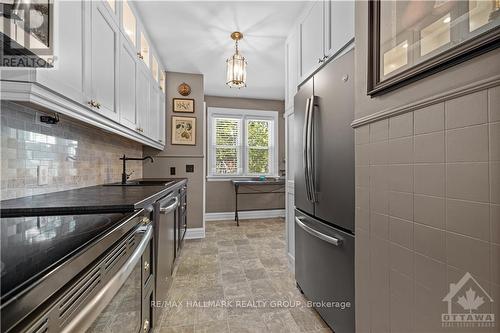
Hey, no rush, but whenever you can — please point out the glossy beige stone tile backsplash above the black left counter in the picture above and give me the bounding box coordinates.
[0,101,142,200]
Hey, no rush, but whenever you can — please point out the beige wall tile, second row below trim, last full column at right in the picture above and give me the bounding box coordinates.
[446,124,488,162]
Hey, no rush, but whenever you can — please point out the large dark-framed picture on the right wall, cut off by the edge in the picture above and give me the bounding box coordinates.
[368,0,500,96]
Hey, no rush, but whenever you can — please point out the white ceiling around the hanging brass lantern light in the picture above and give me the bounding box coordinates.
[135,1,305,99]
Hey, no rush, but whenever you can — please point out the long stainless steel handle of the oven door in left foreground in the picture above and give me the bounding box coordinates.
[61,225,153,333]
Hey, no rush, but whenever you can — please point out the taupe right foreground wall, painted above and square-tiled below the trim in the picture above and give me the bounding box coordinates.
[355,2,500,333]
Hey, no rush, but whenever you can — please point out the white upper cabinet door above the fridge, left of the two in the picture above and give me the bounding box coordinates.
[299,1,324,79]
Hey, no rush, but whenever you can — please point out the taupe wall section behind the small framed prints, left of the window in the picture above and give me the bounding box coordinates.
[143,72,205,228]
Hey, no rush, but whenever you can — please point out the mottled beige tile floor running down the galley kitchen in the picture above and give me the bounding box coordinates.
[155,219,331,333]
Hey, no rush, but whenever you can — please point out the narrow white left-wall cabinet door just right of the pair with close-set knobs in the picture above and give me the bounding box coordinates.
[119,36,137,130]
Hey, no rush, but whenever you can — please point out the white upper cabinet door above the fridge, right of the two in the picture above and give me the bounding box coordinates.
[325,0,354,56]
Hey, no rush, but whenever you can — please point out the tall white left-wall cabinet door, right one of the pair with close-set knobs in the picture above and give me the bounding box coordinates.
[89,2,119,120]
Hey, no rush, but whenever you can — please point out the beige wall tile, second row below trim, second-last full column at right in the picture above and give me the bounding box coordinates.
[414,132,445,163]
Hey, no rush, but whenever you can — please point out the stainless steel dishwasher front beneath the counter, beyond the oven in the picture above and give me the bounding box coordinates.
[154,191,179,301]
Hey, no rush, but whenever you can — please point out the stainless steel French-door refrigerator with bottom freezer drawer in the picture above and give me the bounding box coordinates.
[294,50,355,333]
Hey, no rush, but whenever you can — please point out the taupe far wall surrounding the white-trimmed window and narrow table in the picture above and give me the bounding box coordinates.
[205,96,285,213]
